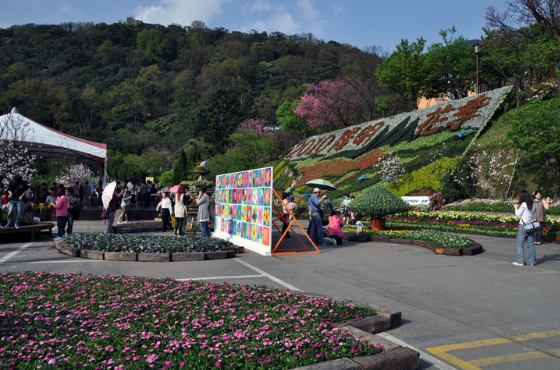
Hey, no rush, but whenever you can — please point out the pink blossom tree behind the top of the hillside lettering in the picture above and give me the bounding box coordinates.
[294,78,357,130]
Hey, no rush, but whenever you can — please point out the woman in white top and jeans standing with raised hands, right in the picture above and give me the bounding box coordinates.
[513,190,537,266]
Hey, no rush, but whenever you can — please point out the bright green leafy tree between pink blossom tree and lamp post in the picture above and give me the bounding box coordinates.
[377,37,427,110]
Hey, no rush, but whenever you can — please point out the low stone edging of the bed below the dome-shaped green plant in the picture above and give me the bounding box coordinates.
[344,232,483,256]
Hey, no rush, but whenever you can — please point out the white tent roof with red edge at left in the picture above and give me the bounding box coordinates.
[0,108,107,165]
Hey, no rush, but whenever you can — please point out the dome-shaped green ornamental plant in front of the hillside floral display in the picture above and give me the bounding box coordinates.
[349,186,410,218]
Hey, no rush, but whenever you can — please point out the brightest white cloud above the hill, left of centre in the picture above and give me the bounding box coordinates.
[134,0,230,26]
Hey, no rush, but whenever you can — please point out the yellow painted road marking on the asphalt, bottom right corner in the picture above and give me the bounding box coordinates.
[426,330,560,370]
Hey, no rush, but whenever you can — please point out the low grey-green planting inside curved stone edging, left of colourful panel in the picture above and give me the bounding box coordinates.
[63,234,233,253]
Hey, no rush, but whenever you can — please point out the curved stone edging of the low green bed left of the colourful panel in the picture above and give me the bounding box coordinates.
[54,240,245,262]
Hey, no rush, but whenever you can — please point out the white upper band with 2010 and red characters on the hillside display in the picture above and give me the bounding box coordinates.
[286,87,511,161]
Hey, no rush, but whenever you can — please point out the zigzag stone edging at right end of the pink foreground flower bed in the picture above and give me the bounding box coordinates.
[295,302,420,370]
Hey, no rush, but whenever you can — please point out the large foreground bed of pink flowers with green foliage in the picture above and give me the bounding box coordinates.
[0,272,382,369]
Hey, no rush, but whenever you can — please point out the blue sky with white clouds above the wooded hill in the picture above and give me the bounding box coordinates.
[0,0,506,52]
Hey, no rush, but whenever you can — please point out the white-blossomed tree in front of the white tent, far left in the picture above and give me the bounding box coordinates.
[0,115,37,186]
